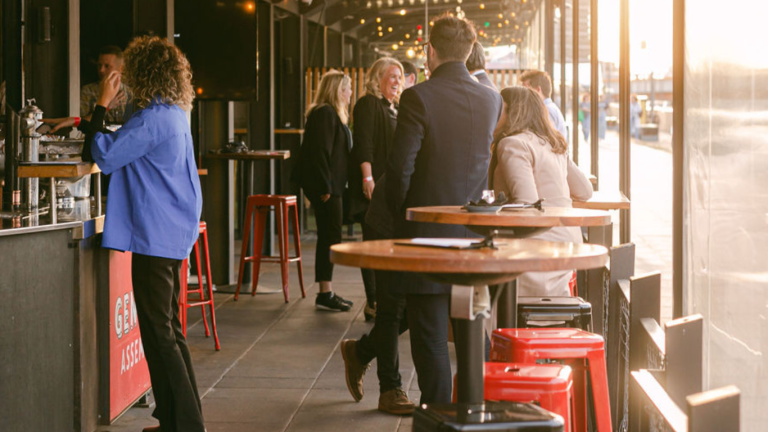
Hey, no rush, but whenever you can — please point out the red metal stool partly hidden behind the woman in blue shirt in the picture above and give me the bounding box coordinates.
[179,222,221,351]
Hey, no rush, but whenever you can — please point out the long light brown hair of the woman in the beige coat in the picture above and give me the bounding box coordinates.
[488,86,568,181]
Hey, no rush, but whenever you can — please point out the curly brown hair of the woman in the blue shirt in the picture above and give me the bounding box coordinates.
[123,36,195,111]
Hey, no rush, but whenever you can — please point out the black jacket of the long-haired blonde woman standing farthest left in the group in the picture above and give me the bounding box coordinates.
[291,105,352,201]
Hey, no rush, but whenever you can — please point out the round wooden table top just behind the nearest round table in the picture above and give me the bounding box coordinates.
[405,206,611,228]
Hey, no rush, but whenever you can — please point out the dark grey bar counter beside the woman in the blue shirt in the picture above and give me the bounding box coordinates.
[0,211,149,432]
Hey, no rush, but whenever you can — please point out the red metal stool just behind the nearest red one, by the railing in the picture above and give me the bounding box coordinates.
[491,328,612,432]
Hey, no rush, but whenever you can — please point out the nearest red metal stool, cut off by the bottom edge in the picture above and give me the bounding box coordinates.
[453,362,575,432]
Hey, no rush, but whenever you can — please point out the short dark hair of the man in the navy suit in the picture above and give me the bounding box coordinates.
[429,14,477,62]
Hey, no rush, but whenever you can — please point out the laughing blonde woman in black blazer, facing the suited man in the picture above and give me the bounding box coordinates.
[348,57,404,321]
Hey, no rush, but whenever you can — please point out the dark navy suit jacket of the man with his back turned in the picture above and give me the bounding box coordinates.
[385,62,502,294]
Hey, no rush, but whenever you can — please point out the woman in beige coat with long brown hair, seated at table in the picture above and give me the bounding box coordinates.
[488,87,592,297]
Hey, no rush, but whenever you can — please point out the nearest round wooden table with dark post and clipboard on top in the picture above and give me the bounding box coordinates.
[331,239,608,412]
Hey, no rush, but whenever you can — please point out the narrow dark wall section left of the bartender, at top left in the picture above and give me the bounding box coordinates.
[24,0,69,117]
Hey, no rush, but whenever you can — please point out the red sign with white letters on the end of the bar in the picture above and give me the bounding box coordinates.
[109,251,151,421]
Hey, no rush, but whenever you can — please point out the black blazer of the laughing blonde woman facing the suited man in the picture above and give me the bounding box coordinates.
[345,95,397,220]
